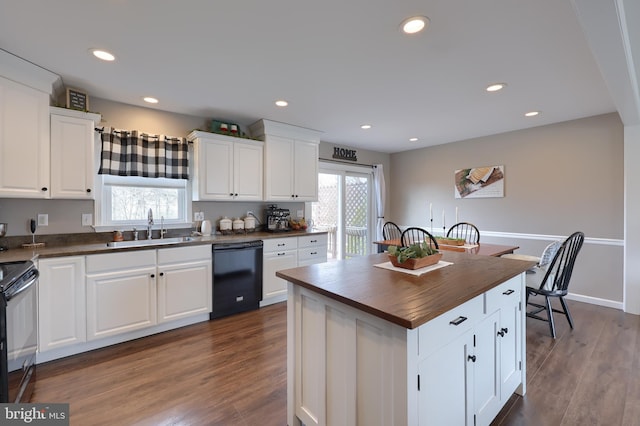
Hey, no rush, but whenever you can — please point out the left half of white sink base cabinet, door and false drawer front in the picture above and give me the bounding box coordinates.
[87,250,157,340]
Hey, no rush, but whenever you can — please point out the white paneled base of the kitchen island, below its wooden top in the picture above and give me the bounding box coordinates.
[287,274,526,426]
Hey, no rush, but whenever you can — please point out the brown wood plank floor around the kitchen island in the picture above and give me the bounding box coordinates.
[33,301,640,426]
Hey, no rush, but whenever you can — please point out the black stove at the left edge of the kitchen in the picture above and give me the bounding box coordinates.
[0,261,39,403]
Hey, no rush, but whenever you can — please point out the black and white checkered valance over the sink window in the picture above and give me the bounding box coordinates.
[98,127,189,179]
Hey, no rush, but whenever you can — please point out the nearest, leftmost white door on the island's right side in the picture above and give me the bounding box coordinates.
[418,330,474,426]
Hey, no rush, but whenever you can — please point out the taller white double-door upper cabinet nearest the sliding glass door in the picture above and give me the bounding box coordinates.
[250,120,321,201]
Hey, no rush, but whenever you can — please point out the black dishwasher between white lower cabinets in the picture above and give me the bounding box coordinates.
[209,241,262,319]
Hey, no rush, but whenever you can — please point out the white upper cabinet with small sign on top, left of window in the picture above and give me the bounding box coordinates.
[51,107,100,199]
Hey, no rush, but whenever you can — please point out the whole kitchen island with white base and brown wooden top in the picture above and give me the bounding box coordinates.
[277,252,533,426]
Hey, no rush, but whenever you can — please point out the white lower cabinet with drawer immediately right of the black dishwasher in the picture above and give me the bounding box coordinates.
[261,237,298,305]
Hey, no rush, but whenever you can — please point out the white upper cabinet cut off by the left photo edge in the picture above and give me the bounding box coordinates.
[0,77,50,198]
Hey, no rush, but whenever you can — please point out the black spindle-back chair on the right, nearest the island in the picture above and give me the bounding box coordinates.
[526,232,584,339]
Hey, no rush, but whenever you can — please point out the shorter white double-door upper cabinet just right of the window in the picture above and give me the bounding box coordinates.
[188,131,264,201]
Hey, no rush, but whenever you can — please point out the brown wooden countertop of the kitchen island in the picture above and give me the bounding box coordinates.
[276,251,535,329]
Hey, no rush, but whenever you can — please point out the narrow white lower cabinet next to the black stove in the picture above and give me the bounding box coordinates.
[38,256,87,352]
